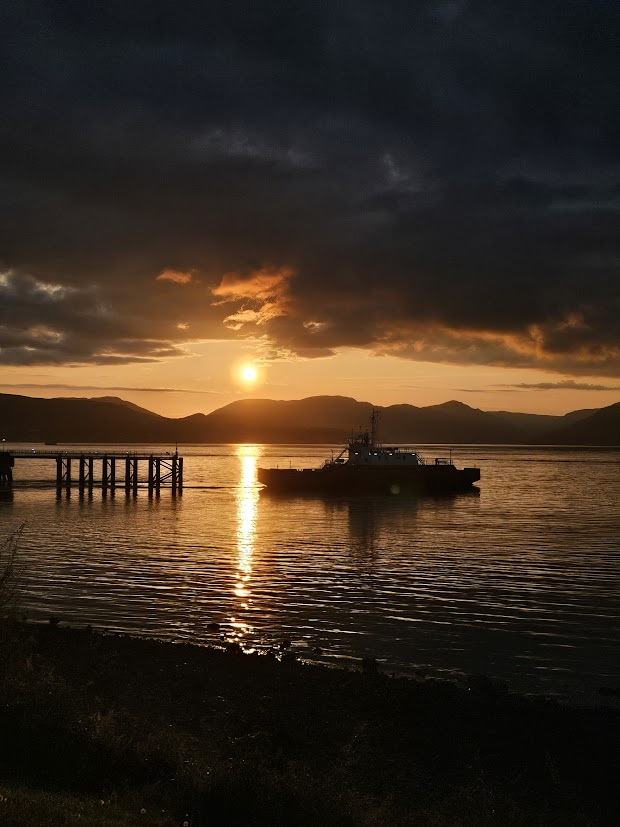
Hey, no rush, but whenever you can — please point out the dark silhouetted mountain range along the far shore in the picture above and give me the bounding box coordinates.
[0,394,620,445]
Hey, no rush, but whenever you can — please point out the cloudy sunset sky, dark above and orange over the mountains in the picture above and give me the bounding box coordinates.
[0,0,620,416]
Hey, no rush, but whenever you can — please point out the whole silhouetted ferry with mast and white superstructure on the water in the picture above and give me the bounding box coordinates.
[257,410,480,496]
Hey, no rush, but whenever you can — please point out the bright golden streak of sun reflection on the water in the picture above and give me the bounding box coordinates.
[230,445,261,643]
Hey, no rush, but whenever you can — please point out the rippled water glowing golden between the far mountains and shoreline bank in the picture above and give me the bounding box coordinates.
[0,445,620,703]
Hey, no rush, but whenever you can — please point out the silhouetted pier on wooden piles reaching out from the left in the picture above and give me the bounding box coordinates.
[0,448,183,497]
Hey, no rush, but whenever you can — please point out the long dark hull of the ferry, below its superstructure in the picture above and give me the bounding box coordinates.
[257,465,480,496]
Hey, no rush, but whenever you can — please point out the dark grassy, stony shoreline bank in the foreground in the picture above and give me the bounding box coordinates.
[0,623,620,827]
